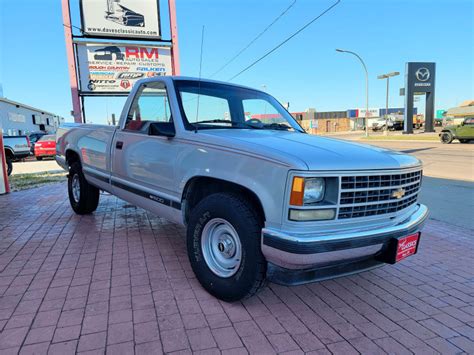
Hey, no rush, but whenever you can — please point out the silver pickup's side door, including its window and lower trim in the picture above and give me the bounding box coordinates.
[111,82,181,222]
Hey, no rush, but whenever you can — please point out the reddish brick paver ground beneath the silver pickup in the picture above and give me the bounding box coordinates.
[0,184,474,354]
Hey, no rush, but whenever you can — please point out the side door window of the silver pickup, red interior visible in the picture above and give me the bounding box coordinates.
[124,82,173,133]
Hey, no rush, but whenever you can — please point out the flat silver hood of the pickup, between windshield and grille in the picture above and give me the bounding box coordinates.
[200,129,421,170]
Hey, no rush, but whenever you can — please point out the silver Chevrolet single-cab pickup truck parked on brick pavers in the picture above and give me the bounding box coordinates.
[56,77,428,301]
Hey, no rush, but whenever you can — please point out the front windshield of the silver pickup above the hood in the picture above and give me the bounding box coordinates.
[175,80,304,132]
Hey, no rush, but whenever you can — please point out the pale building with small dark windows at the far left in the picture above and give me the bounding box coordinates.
[0,97,64,136]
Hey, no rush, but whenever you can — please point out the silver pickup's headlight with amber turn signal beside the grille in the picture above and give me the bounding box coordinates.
[290,176,326,206]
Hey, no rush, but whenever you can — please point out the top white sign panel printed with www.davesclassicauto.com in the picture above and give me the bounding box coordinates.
[81,0,160,39]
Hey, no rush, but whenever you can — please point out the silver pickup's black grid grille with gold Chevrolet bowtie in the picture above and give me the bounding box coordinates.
[338,170,422,219]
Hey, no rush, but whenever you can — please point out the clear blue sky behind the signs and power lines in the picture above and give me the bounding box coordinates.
[0,0,474,123]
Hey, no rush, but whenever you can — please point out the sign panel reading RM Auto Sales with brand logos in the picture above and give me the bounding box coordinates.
[76,43,172,94]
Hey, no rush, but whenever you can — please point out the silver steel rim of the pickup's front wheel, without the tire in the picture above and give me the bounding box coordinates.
[201,218,242,278]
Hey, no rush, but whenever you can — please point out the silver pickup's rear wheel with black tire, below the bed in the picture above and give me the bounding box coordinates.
[67,163,99,214]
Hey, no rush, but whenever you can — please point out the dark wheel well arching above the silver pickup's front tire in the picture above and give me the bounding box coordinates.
[182,176,265,223]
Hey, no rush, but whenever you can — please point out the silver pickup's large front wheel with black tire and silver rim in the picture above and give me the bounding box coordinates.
[187,193,267,302]
